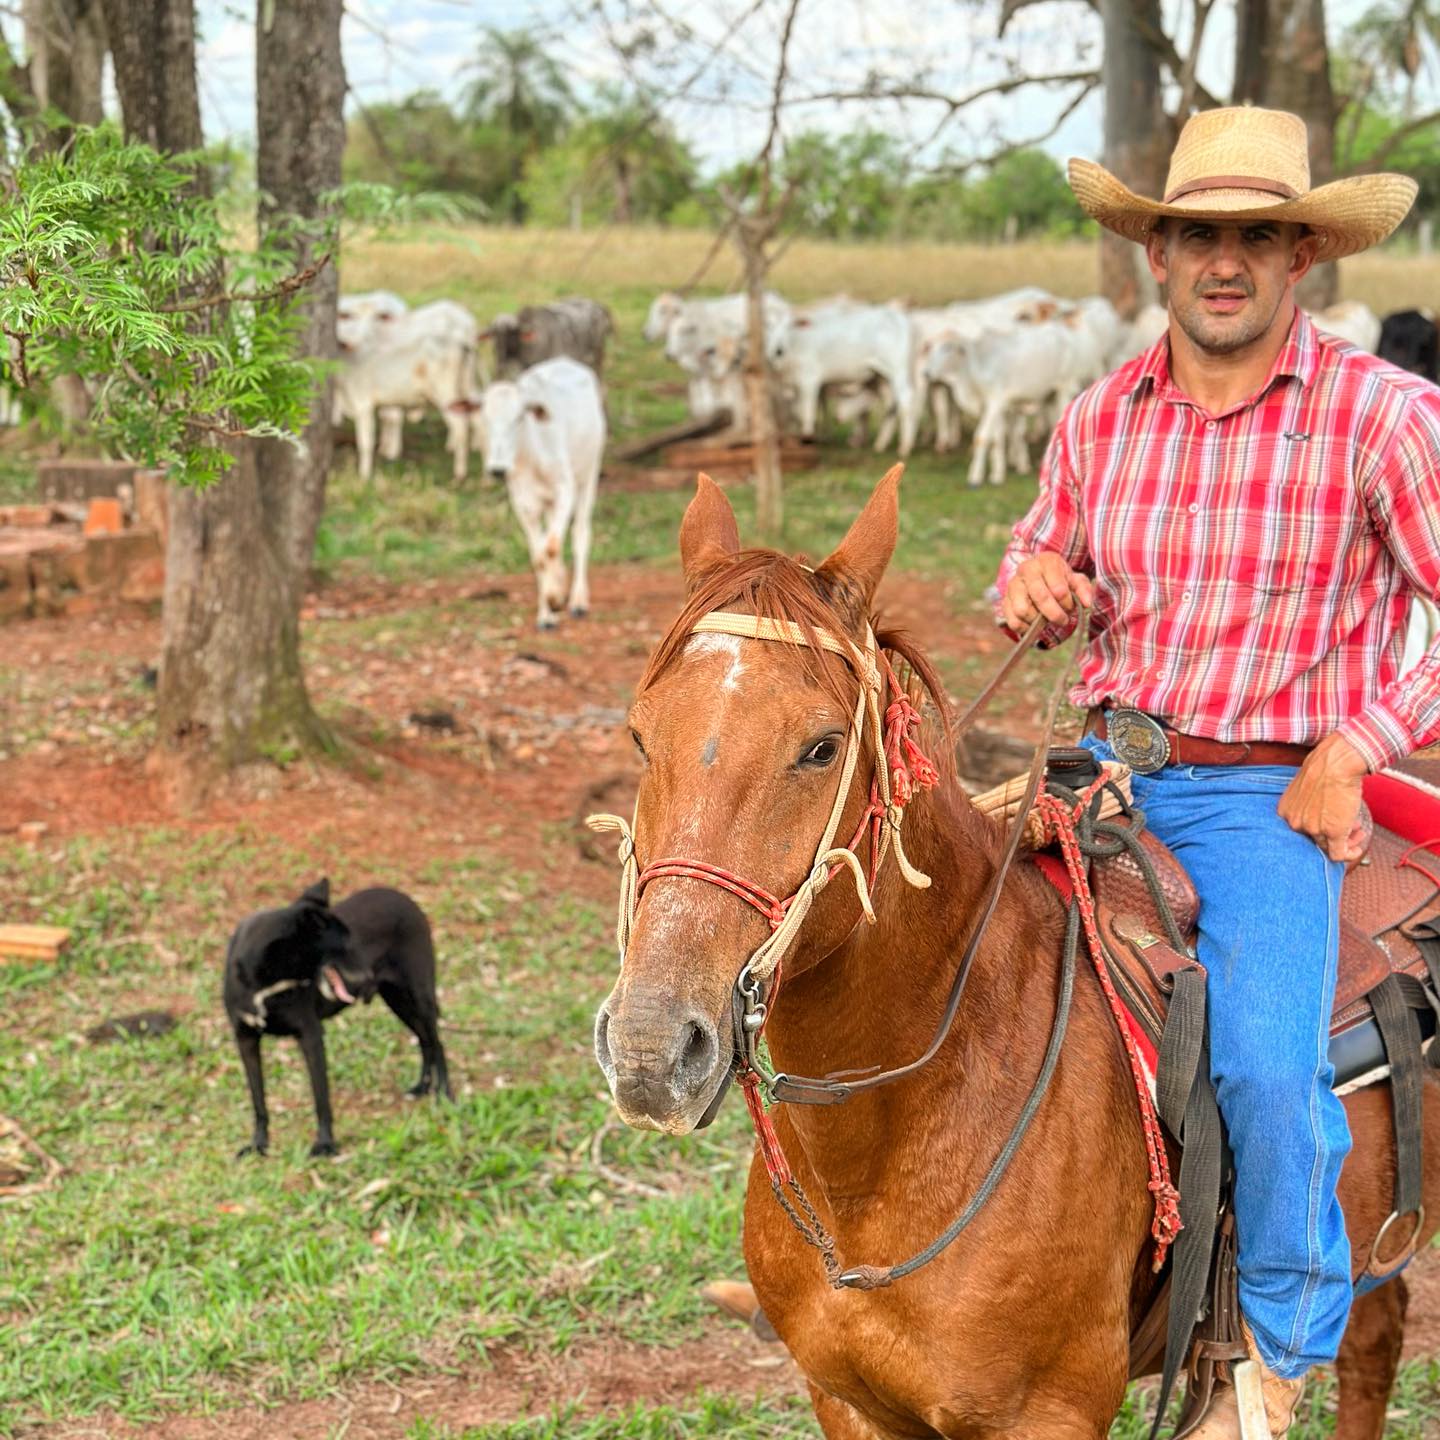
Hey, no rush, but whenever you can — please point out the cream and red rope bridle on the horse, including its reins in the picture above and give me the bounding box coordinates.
[586,609,1089,1289]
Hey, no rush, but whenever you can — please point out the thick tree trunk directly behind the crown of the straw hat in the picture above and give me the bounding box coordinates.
[1236,0,1341,308]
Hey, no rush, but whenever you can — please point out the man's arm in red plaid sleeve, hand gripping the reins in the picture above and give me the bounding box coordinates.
[995,410,1094,645]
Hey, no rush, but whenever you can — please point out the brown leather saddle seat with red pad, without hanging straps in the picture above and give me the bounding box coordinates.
[1071,759,1440,1059]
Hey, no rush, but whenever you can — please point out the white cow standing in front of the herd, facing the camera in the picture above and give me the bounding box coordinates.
[474,356,605,629]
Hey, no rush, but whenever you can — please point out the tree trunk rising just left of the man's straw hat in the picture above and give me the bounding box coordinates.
[1100,0,1175,320]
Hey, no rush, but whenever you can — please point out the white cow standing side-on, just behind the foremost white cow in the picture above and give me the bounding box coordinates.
[336,336,475,481]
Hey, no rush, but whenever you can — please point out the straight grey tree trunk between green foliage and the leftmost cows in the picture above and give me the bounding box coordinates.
[255,0,346,611]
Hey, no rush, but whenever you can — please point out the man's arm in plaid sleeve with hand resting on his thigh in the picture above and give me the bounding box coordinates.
[1280,392,1440,860]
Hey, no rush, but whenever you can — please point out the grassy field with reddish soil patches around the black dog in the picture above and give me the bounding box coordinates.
[0,229,1440,1440]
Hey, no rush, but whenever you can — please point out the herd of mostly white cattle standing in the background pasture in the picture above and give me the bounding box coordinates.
[324,287,1440,628]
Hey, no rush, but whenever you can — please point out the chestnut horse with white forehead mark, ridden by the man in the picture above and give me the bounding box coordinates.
[595,469,1440,1440]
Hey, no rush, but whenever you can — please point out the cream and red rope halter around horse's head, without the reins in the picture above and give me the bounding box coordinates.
[586,611,939,982]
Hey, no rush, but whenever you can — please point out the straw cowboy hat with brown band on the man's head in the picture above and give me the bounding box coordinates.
[1070,105,1418,261]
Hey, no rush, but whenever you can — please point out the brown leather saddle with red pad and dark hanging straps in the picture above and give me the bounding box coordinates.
[1034,750,1440,1440]
